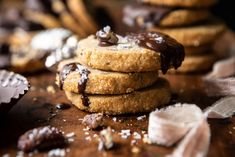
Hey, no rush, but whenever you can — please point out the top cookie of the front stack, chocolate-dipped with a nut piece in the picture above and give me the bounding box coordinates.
[76,27,184,73]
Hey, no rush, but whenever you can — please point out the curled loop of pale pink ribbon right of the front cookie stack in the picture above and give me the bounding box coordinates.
[148,104,203,146]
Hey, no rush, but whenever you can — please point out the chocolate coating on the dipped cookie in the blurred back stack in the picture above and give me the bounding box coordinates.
[123,4,177,28]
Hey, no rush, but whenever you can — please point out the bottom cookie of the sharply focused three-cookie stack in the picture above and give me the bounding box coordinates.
[65,79,171,115]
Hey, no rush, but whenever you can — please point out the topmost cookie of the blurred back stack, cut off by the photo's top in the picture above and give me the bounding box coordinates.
[140,0,217,8]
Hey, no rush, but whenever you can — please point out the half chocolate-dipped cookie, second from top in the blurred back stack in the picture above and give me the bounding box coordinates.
[123,4,210,28]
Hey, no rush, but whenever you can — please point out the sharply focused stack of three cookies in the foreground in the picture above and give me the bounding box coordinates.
[57,26,184,115]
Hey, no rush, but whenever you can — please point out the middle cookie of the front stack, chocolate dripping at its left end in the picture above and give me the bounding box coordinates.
[57,60,158,94]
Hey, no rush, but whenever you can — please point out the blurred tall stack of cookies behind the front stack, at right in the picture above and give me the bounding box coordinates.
[123,0,225,73]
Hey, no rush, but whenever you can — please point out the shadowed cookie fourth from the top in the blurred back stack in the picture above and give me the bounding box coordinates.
[184,44,212,56]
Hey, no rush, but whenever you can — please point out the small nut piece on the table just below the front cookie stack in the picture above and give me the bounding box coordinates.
[82,113,103,129]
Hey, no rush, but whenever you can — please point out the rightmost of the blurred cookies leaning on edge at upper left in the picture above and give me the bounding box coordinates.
[66,0,97,34]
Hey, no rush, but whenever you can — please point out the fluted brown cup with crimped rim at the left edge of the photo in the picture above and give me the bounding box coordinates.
[0,70,29,114]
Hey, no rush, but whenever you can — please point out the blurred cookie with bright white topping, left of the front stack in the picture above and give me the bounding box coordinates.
[11,28,77,73]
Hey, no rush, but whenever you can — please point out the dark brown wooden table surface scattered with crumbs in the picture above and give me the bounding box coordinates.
[0,72,235,157]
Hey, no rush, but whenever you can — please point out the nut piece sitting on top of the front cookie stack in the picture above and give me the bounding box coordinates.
[96,26,118,46]
